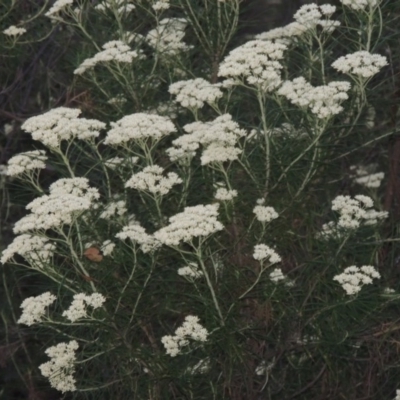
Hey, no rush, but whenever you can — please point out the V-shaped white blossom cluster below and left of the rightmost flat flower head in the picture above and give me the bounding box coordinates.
[278,77,351,119]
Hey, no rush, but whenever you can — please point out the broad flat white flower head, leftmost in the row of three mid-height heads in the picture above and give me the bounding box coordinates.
[22,107,106,148]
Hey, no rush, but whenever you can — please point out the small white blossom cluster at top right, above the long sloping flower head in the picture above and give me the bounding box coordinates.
[293,3,340,32]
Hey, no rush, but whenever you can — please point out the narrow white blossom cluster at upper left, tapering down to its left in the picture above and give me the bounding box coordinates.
[74,40,143,75]
